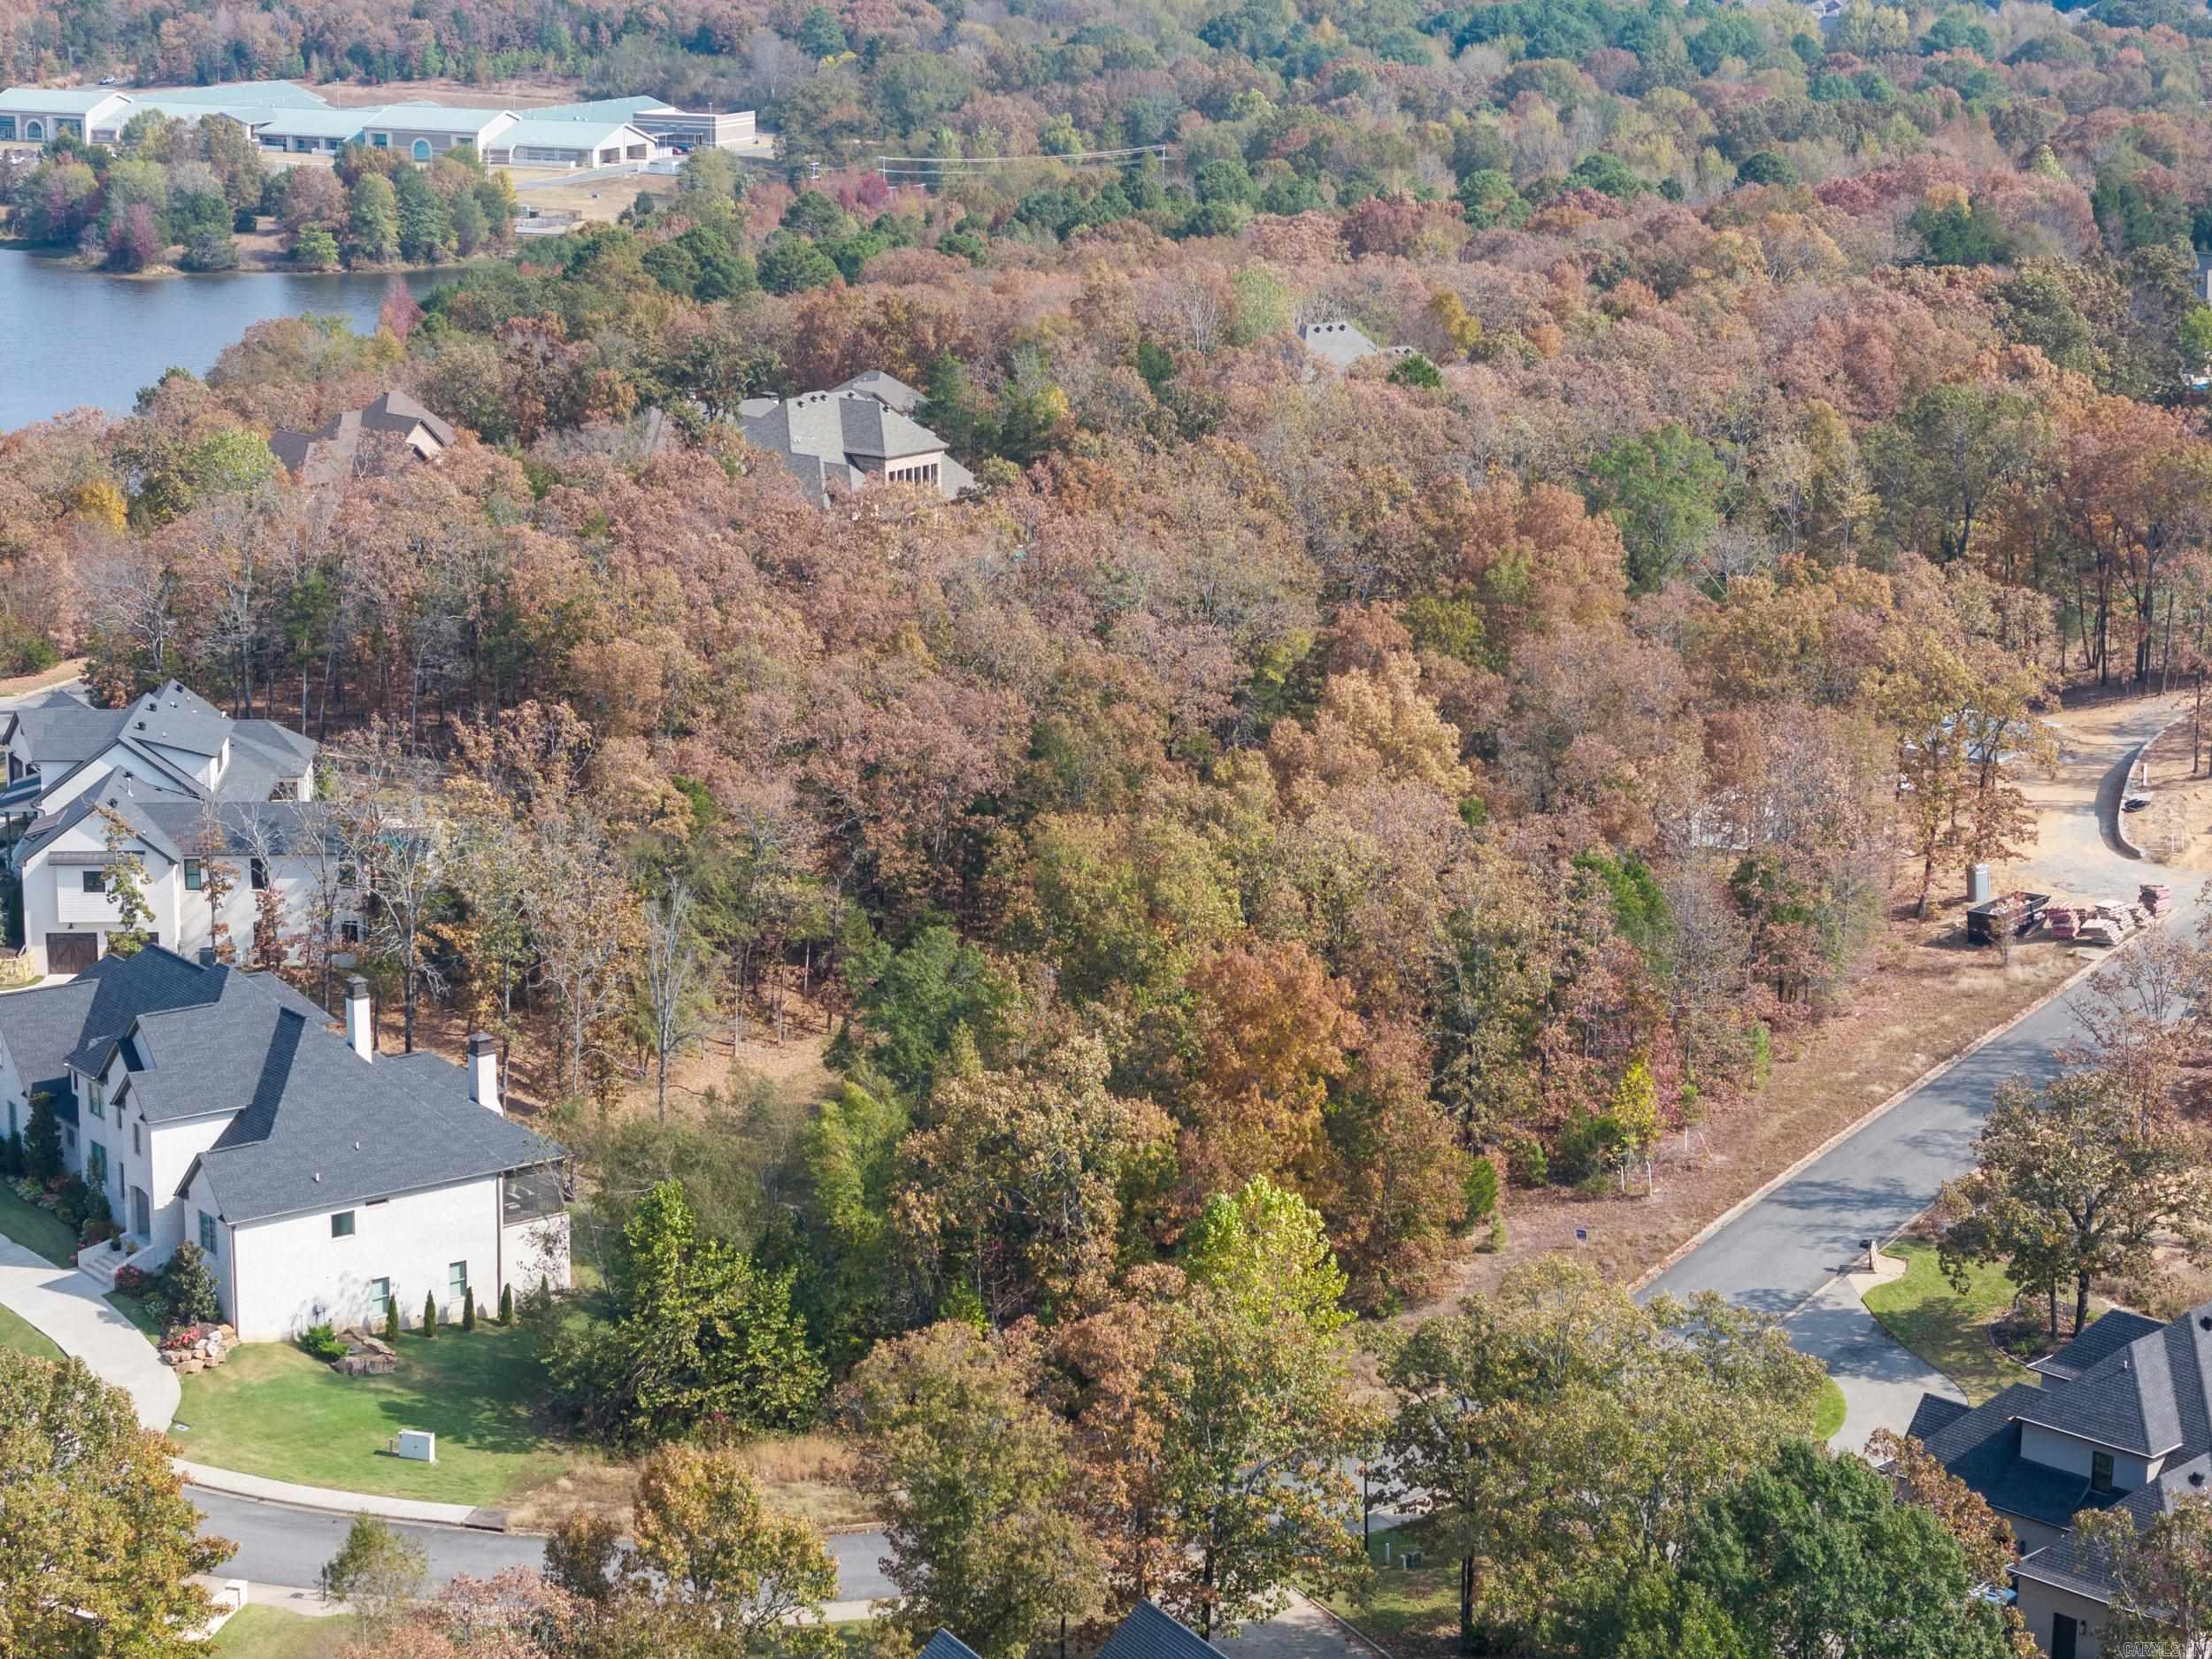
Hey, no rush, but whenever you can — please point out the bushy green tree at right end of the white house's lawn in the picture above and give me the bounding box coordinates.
[549,1181,826,1445]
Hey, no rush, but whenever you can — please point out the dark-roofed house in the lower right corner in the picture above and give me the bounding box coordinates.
[1911,1303,2212,1659]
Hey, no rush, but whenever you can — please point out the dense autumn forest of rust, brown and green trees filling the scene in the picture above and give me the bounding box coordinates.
[21,0,2212,1659]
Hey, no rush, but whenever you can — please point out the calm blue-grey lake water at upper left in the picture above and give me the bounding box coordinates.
[0,250,441,432]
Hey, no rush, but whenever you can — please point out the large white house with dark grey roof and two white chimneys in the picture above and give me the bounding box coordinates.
[0,947,569,1343]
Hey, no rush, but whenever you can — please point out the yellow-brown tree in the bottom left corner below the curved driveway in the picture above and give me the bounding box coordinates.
[0,1348,233,1659]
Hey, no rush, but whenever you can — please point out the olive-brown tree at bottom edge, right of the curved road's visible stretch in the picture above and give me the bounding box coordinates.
[845,1321,1104,1659]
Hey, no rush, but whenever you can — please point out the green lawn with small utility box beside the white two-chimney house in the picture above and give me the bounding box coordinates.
[173,1325,595,1504]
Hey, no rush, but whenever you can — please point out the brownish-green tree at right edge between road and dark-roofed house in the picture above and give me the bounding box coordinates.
[1938,1071,2212,1336]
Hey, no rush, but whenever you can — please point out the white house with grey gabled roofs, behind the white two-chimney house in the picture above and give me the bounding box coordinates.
[0,680,325,973]
